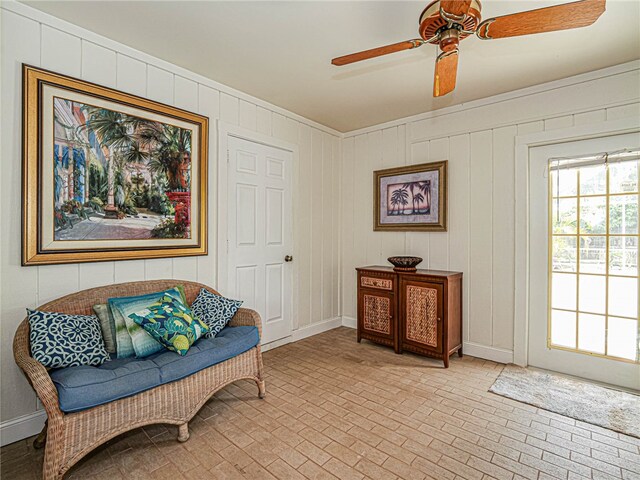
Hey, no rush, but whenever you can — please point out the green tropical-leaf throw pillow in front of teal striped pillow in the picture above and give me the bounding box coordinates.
[129,295,209,355]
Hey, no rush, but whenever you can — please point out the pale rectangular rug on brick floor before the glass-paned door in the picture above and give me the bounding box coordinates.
[489,365,640,438]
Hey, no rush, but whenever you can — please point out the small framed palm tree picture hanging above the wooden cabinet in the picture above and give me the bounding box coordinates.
[373,160,447,232]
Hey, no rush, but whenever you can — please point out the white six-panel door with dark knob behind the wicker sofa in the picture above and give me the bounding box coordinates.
[226,135,293,344]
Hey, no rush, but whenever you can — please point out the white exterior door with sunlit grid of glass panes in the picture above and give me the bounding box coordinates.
[528,133,640,389]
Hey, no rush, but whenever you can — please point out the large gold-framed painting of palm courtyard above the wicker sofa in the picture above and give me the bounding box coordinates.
[22,65,208,265]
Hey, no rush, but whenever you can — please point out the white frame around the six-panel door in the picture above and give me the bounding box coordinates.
[216,120,299,332]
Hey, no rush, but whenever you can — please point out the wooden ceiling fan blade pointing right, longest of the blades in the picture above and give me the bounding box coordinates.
[476,0,606,40]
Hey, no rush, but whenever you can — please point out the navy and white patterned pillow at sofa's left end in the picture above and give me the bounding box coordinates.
[27,309,109,368]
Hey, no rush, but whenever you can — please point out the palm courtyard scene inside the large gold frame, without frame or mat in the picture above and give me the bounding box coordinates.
[52,97,193,241]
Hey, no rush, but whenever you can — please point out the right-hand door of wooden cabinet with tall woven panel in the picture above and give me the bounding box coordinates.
[400,281,444,353]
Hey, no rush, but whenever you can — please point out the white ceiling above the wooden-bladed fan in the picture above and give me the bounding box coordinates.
[24,0,640,132]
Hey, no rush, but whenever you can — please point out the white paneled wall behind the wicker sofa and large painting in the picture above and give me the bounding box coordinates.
[0,4,341,432]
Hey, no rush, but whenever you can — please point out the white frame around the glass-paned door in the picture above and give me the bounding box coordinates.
[513,117,640,367]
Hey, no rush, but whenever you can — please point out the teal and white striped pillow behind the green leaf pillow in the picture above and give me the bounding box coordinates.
[107,287,186,358]
